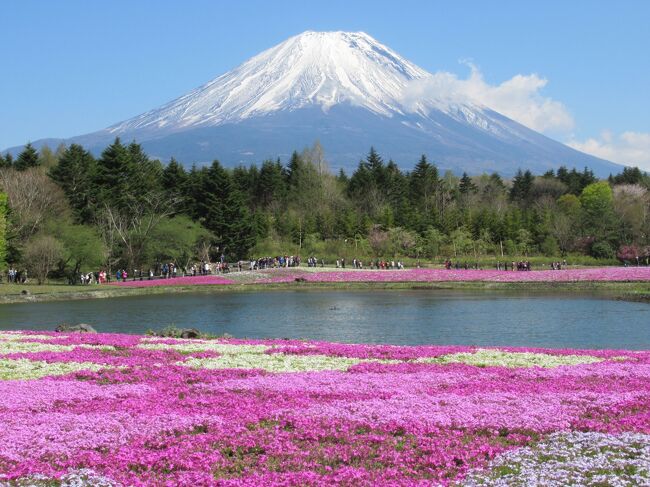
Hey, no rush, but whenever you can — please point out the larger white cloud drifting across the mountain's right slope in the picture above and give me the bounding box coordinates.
[404,62,575,136]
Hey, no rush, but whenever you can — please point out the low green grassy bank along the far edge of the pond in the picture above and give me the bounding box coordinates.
[0,281,650,304]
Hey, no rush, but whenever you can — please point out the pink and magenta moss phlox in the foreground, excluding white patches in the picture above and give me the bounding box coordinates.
[0,330,650,486]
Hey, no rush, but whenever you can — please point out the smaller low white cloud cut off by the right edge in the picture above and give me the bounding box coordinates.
[567,130,650,171]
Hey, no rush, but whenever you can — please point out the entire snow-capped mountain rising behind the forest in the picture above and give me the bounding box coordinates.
[8,31,621,175]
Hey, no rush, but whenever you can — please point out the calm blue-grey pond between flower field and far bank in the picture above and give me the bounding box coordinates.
[0,290,650,350]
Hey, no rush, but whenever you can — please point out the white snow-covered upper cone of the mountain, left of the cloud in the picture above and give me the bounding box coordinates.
[110,31,429,133]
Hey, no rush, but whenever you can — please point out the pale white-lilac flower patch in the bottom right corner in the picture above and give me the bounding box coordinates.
[460,432,650,487]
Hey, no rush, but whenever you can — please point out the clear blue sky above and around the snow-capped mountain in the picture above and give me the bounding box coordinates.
[0,0,650,168]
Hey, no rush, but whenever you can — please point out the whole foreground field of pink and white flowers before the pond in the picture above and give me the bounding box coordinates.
[0,332,650,486]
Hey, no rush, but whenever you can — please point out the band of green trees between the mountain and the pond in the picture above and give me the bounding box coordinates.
[0,139,650,282]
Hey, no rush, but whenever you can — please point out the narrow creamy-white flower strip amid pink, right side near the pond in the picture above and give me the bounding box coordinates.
[417,349,603,368]
